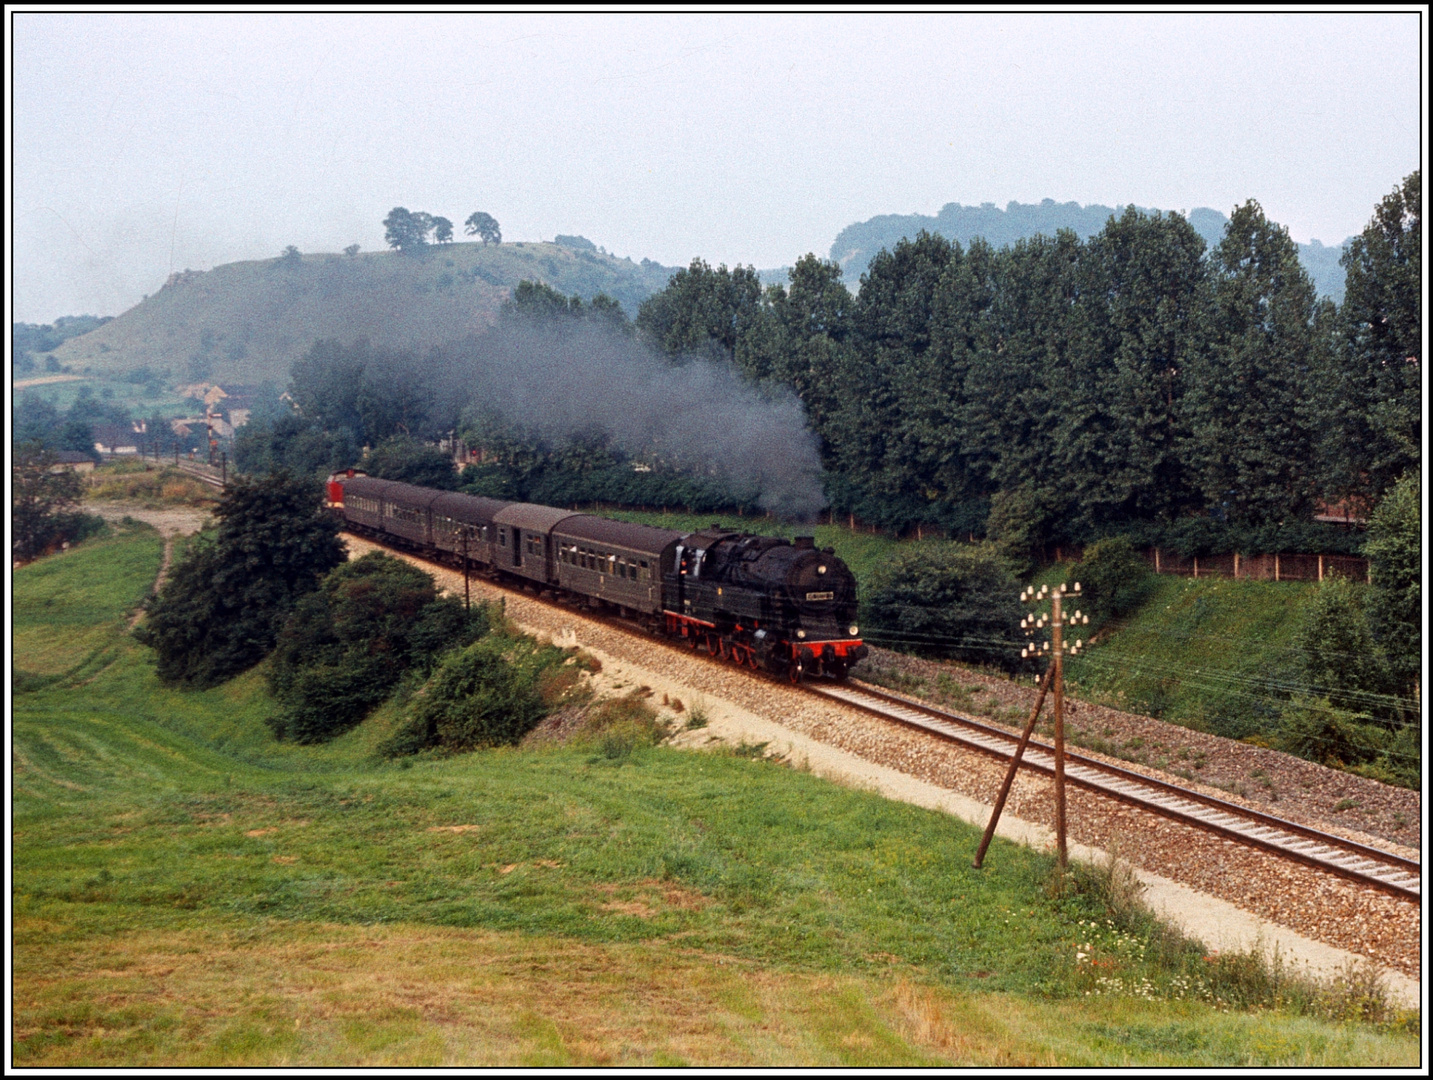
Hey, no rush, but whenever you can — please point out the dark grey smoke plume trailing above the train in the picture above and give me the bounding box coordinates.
[438,324,825,519]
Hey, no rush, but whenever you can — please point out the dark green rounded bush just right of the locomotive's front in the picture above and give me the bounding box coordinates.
[861,544,1020,669]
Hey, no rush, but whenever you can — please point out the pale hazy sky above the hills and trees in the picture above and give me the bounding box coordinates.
[7,13,1426,322]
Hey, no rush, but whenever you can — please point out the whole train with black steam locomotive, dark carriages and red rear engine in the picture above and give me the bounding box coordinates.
[328,476,867,682]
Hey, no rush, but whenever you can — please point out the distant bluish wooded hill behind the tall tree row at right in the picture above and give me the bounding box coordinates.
[825,199,1348,302]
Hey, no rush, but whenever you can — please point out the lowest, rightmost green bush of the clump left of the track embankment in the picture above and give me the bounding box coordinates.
[383,630,567,756]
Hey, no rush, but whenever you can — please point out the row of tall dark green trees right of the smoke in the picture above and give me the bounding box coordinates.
[636,173,1422,550]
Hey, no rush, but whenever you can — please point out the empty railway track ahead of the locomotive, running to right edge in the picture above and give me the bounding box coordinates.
[807,683,1422,902]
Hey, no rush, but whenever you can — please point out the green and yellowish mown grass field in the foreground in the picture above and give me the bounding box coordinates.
[11,527,1419,1067]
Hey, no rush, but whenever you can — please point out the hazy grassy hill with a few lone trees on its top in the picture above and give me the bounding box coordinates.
[53,236,675,384]
